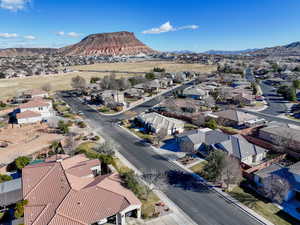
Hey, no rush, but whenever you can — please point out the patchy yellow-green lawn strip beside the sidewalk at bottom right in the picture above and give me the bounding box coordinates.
[228,187,300,225]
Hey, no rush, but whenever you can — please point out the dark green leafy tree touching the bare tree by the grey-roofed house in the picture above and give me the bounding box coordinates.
[201,150,226,182]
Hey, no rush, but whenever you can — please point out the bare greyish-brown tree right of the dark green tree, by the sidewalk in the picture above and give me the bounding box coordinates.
[219,155,243,190]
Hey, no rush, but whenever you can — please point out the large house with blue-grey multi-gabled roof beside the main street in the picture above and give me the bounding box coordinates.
[176,128,267,165]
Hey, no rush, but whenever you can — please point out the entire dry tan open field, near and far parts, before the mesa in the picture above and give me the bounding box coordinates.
[0,61,215,99]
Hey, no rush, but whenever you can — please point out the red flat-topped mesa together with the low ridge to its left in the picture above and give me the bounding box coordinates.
[0,31,156,57]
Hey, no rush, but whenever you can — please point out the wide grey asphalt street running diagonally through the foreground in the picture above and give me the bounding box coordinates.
[63,92,260,225]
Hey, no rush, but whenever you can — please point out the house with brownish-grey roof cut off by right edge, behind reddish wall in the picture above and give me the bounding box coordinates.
[258,122,300,151]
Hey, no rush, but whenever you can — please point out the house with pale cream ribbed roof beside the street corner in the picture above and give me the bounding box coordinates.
[137,112,184,135]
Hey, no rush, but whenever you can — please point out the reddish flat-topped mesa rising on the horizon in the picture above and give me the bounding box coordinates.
[60,31,155,56]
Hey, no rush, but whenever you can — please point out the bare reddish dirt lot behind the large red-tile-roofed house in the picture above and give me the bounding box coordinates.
[0,125,62,164]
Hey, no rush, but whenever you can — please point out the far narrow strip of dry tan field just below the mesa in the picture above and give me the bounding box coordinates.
[70,61,216,72]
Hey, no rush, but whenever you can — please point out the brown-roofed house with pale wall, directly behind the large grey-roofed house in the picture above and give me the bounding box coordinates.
[213,109,258,127]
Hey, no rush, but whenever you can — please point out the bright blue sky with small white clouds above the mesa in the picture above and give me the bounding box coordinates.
[0,0,300,51]
